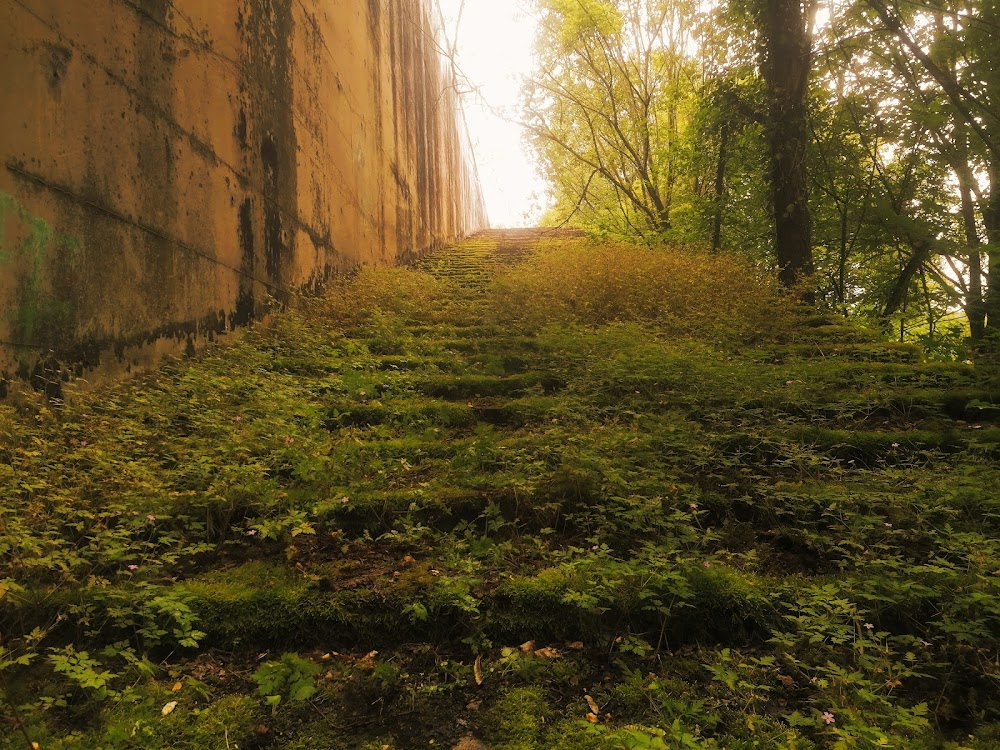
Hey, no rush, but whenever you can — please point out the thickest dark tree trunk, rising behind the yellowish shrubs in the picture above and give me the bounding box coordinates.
[759,0,813,287]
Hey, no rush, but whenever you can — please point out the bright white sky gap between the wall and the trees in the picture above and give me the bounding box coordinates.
[438,0,547,227]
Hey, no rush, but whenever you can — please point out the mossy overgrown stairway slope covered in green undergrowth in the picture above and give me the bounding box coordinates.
[0,233,1000,750]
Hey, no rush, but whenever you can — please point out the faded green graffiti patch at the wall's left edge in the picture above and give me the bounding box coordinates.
[0,192,80,344]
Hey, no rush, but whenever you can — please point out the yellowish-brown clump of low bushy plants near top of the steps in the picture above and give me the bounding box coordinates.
[491,240,792,340]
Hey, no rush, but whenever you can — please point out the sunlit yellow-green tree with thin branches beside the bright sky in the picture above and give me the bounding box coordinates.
[524,0,697,236]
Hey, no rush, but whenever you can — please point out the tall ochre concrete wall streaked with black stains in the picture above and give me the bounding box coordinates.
[0,0,486,400]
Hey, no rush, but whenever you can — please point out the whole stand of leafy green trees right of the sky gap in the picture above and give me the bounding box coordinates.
[523,0,1000,351]
